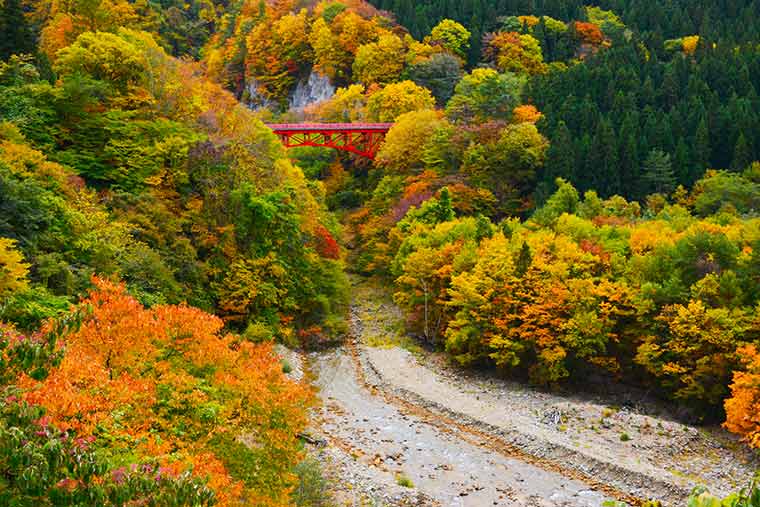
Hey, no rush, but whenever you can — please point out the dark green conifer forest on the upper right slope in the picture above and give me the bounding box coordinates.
[364,1,760,199]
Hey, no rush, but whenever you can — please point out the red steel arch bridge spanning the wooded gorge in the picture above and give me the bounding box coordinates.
[267,123,393,158]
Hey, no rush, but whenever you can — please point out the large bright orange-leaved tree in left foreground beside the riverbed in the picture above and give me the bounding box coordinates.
[20,278,313,506]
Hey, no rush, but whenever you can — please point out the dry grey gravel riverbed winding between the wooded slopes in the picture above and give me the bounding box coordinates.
[289,278,757,507]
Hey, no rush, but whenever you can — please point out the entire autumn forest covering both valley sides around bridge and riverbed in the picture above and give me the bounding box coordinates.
[0,0,760,506]
